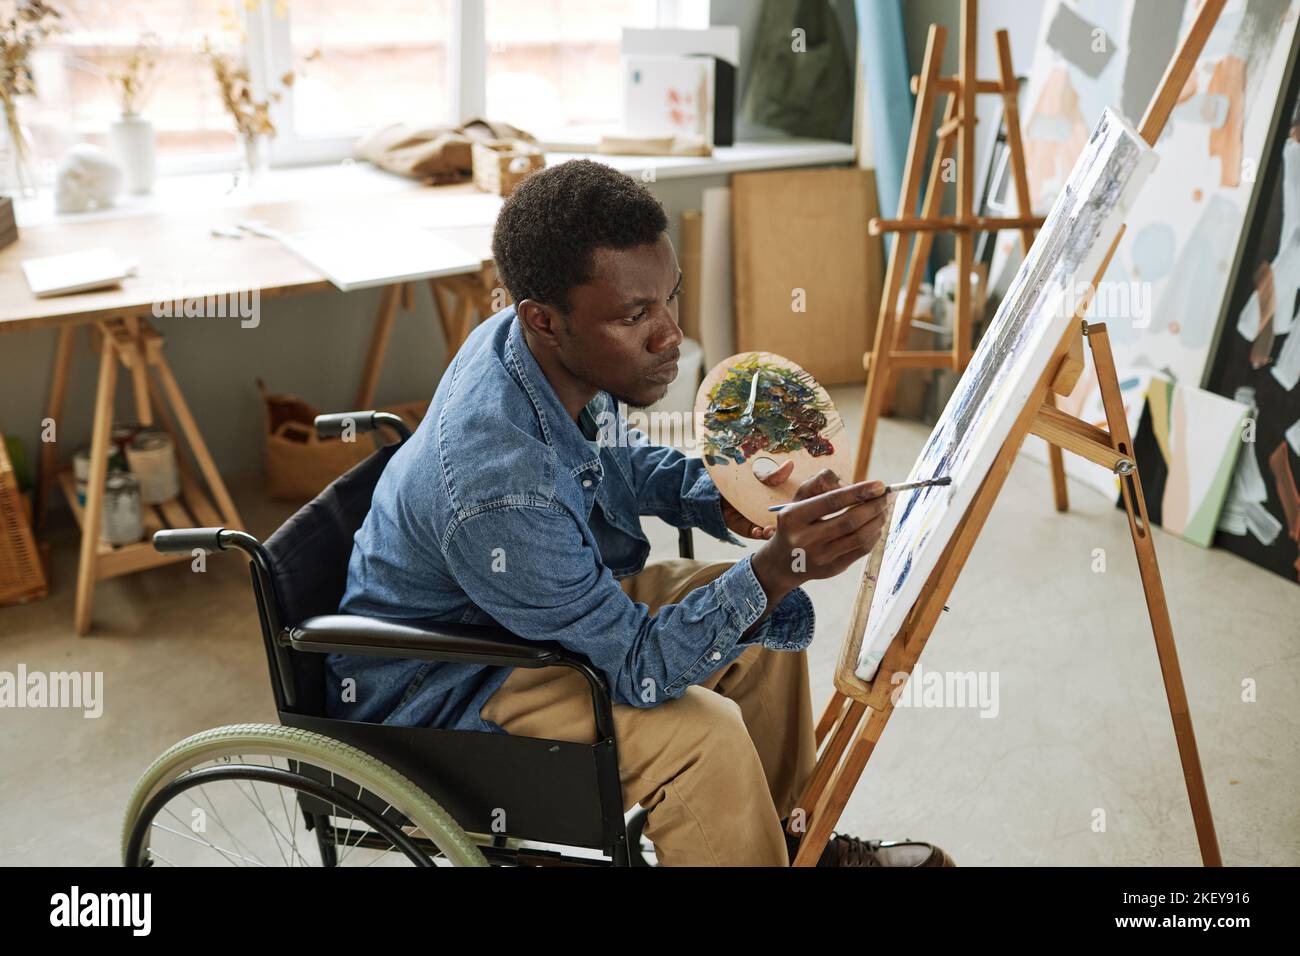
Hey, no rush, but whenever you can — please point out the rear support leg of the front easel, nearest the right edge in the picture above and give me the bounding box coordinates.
[1088,326,1223,866]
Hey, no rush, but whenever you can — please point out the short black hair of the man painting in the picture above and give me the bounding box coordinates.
[491,160,668,313]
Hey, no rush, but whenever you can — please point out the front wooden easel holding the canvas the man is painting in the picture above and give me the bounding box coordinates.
[789,0,1226,866]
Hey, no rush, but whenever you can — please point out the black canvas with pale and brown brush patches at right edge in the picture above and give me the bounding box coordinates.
[1209,65,1300,581]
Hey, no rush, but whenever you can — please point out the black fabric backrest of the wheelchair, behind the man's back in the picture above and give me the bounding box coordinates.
[265,445,400,717]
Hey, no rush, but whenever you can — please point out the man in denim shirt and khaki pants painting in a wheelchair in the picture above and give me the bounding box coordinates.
[328,160,950,866]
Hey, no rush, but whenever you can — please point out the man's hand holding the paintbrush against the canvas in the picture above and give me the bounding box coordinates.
[751,468,888,606]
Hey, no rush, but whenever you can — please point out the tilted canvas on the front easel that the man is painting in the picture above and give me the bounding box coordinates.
[858,111,1156,680]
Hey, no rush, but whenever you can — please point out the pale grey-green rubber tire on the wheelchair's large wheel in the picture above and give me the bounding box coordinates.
[122,723,488,866]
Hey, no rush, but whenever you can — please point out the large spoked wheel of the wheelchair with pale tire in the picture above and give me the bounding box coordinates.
[122,723,488,866]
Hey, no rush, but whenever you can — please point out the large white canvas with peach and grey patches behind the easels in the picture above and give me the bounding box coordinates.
[992,0,1300,498]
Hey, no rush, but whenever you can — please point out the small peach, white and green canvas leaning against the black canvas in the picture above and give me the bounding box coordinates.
[1132,376,1251,548]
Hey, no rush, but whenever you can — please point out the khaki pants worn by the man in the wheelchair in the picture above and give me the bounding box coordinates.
[481,559,816,866]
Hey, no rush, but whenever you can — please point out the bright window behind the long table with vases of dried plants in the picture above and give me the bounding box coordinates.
[20,0,709,177]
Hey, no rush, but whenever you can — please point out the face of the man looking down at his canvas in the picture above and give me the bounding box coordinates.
[556,234,683,408]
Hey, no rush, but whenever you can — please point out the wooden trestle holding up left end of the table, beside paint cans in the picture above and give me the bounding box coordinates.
[36,315,243,635]
